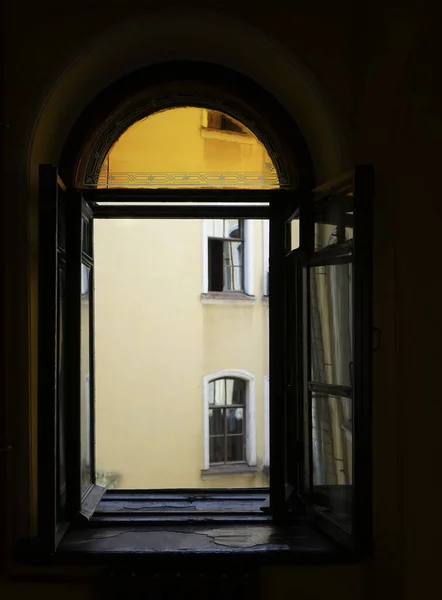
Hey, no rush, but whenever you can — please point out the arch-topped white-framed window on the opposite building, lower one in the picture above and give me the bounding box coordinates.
[203,369,256,470]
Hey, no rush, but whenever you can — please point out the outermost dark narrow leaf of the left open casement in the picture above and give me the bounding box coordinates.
[38,165,69,551]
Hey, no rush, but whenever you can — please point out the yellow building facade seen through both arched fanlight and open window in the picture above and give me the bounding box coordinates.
[90,107,277,489]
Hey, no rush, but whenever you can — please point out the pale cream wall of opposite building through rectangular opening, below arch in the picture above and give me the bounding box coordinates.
[92,219,269,490]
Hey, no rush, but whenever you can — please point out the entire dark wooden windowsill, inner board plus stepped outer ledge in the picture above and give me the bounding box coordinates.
[17,488,357,578]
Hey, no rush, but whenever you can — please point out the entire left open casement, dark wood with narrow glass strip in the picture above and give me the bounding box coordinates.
[38,165,105,551]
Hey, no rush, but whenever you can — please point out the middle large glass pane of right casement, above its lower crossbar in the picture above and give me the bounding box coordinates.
[310,264,353,387]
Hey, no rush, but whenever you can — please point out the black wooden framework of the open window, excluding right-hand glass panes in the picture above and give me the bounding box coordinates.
[38,165,373,552]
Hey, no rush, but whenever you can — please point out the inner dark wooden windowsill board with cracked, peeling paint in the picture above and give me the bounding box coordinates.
[21,518,354,573]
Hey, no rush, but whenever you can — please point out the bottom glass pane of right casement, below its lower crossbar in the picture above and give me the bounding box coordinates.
[312,394,353,530]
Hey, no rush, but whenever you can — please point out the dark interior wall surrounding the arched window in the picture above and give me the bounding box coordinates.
[0,0,442,600]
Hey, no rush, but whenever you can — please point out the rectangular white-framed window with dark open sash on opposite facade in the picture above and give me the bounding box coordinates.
[202,219,255,296]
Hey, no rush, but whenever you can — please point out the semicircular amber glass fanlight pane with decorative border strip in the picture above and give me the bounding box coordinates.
[87,107,279,189]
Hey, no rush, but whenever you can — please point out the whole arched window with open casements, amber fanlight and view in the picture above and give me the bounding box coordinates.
[39,57,372,548]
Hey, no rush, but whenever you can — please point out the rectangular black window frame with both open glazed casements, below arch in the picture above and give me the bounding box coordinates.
[39,165,373,551]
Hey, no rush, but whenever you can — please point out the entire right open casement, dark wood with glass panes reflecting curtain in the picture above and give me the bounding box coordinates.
[284,167,373,550]
